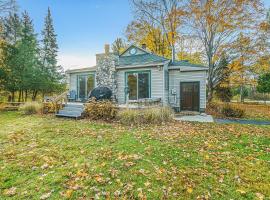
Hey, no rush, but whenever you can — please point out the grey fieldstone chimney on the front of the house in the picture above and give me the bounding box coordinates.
[96,44,118,100]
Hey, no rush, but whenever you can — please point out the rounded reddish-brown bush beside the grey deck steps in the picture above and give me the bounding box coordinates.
[85,99,118,121]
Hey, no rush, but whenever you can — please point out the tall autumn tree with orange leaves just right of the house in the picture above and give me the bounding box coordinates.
[185,0,262,101]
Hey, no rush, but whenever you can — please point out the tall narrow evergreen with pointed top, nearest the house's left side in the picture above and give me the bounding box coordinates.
[41,8,63,92]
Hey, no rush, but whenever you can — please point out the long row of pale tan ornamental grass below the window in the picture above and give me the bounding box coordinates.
[118,107,173,125]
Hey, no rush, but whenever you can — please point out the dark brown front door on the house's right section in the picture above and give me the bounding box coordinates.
[180,82,200,111]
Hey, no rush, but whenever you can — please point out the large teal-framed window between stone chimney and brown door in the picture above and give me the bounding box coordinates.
[126,71,151,100]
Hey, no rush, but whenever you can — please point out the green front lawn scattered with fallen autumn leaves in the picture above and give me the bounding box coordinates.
[0,112,270,200]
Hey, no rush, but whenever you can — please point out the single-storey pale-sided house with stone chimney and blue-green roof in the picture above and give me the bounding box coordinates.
[66,45,208,112]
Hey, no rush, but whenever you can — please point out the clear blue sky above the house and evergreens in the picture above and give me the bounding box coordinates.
[17,0,270,70]
